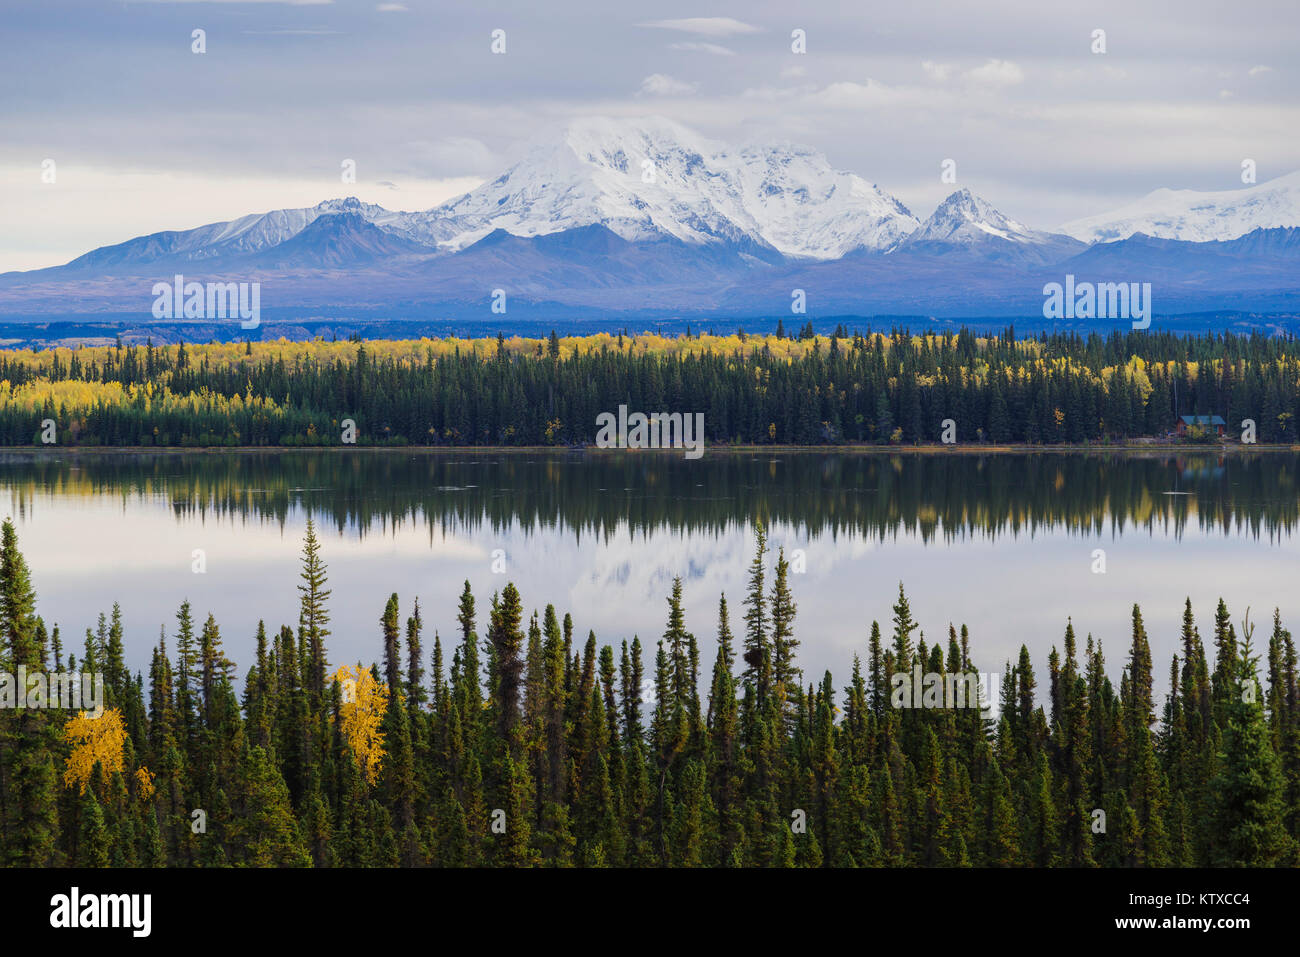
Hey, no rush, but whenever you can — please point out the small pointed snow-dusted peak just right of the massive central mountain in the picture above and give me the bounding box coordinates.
[897,189,1084,261]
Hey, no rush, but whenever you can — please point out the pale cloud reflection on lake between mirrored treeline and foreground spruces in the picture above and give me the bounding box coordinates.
[17,495,1300,712]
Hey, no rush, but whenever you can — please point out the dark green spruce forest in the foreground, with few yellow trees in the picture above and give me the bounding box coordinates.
[0,521,1300,867]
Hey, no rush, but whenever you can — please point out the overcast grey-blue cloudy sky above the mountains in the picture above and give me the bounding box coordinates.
[0,0,1300,272]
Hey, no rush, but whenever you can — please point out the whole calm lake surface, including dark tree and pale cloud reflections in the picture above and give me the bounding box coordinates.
[0,450,1300,690]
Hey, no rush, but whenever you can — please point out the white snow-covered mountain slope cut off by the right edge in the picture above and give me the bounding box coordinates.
[1061,170,1300,243]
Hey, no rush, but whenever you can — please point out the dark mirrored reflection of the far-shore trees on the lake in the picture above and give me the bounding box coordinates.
[0,450,1300,541]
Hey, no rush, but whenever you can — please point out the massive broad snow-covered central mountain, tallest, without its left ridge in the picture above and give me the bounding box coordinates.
[400,117,918,259]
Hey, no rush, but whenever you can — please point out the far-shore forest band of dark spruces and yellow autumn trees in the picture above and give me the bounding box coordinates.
[0,326,1300,446]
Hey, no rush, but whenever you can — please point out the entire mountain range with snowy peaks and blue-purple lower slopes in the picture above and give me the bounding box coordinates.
[0,118,1300,324]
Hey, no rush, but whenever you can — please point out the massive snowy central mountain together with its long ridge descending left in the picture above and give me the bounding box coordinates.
[38,117,920,272]
